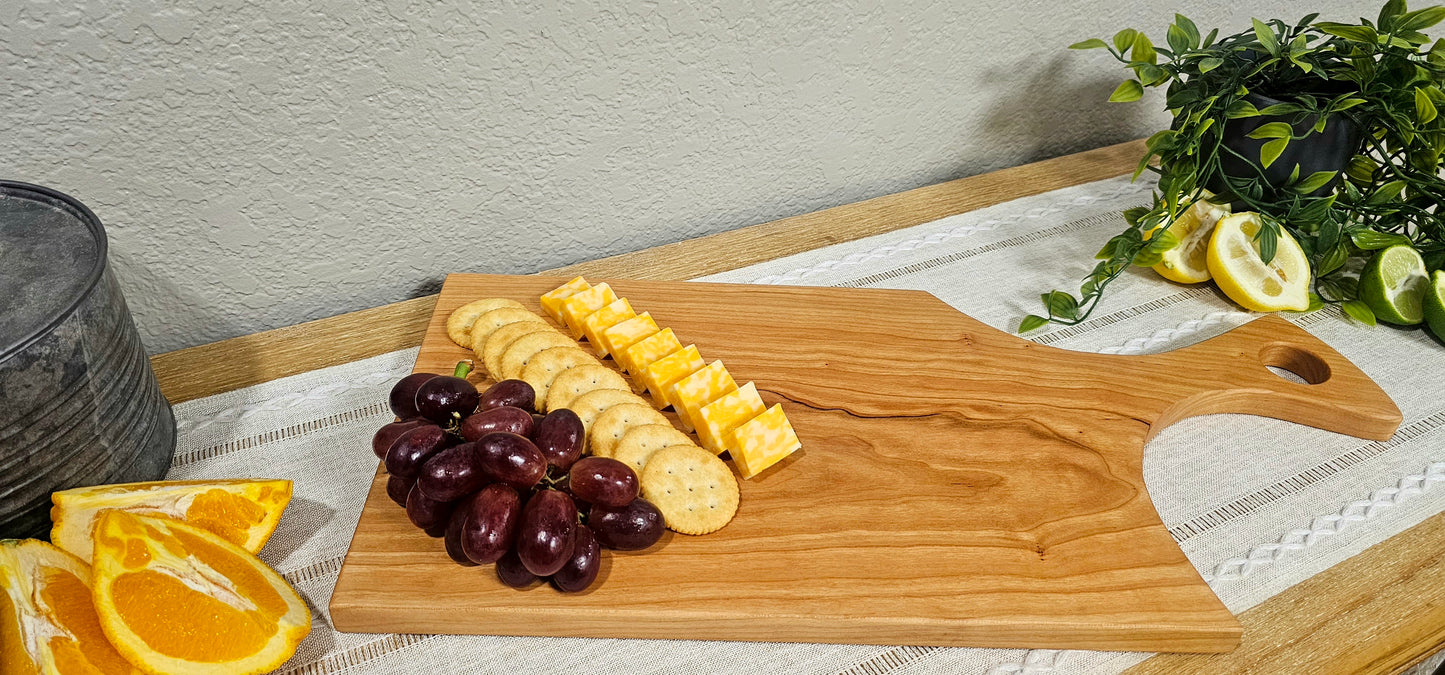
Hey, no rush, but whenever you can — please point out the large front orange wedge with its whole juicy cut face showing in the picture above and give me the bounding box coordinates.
[92,510,311,675]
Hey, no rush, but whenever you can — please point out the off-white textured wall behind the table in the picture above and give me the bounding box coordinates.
[0,0,1379,351]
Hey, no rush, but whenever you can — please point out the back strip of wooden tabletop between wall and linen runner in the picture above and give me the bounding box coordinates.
[150,140,1144,403]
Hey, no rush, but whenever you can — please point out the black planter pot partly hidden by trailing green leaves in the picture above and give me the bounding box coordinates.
[1208,94,1364,197]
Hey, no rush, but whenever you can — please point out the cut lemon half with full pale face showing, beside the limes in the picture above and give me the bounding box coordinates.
[1205,211,1309,312]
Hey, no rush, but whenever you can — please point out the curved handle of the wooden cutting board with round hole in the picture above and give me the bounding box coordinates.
[1150,317,1403,441]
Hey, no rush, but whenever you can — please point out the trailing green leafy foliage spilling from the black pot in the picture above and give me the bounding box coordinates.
[1019,0,1445,332]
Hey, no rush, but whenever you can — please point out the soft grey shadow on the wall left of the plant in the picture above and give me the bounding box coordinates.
[983,52,1150,166]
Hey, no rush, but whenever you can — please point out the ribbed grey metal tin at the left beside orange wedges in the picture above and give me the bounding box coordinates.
[0,184,175,538]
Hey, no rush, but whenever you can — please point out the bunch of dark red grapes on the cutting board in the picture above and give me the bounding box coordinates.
[371,361,663,593]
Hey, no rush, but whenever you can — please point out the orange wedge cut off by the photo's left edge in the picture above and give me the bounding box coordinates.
[0,539,140,675]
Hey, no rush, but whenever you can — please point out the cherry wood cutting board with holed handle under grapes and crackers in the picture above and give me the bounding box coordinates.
[331,275,1400,652]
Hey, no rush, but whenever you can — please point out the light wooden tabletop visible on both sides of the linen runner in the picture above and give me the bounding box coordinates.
[150,140,1445,674]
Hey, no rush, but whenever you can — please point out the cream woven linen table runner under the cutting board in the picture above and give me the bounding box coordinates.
[169,178,1445,675]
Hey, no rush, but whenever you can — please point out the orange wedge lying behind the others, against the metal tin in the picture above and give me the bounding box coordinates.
[51,480,290,562]
